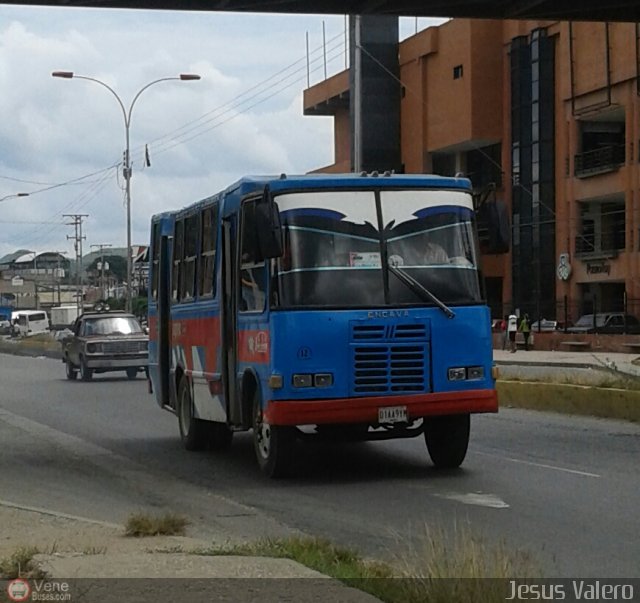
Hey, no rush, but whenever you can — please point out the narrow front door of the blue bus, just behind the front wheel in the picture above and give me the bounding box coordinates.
[221,216,242,425]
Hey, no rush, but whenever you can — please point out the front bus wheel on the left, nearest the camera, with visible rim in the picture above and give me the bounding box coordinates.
[252,392,295,478]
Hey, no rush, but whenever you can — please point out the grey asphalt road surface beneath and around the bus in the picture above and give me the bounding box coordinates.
[0,355,640,578]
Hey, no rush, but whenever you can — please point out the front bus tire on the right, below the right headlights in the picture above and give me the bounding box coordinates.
[424,414,471,469]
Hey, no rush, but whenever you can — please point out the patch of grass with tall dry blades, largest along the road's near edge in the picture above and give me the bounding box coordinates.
[198,526,541,603]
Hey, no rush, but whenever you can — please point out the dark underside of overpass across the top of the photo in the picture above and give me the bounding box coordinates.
[3,0,640,22]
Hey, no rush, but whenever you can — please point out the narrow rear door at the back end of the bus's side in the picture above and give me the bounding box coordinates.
[155,235,171,406]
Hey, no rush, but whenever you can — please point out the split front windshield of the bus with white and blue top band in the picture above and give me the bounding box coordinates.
[277,190,482,308]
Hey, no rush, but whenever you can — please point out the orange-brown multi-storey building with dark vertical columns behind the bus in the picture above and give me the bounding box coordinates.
[304,19,640,322]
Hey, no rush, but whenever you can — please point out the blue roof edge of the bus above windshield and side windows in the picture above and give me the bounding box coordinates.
[152,172,471,222]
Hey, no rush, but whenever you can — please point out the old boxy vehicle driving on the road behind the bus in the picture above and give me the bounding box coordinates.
[62,311,149,381]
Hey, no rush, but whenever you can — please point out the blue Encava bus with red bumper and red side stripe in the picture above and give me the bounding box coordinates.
[148,173,498,477]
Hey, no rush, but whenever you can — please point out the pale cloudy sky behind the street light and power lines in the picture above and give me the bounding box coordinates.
[0,4,442,258]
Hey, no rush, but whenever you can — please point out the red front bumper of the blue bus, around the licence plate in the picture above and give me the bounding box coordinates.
[265,389,498,425]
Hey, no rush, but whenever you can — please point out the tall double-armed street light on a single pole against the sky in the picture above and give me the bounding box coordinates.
[51,71,200,312]
